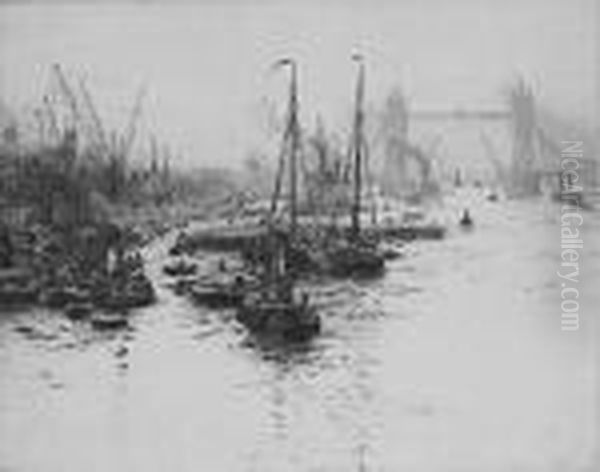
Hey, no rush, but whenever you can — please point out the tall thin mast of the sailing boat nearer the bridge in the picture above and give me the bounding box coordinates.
[352,55,365,236]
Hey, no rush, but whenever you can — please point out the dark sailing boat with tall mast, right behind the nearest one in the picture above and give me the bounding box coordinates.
[326,55,385,277]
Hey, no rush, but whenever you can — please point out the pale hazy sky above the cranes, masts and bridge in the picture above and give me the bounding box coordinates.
[0,0,597,168]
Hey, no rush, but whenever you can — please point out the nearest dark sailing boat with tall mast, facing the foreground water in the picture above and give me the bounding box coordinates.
[236,59,321,341]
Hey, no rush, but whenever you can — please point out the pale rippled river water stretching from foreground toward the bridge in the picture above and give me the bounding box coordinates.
[0,191,600,472]
